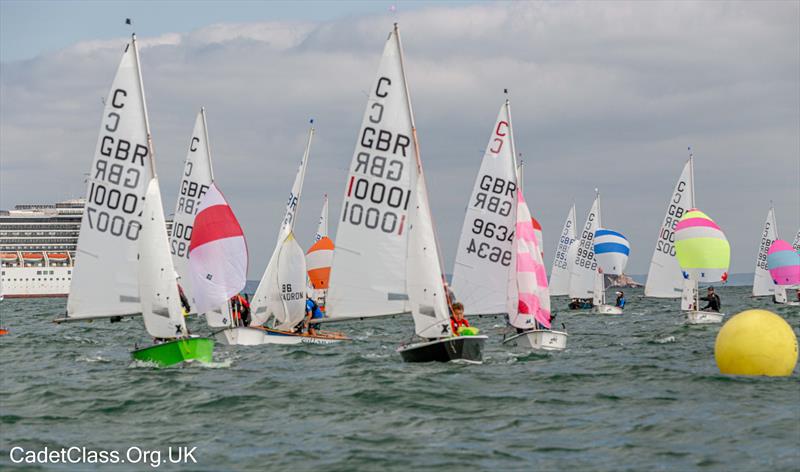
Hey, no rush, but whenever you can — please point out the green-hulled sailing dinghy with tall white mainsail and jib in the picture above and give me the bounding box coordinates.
[55,35,214,366]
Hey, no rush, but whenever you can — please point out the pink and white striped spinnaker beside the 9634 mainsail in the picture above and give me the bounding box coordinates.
[509,190,550,329]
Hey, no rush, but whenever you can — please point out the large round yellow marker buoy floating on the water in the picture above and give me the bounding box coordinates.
[714,310,797,377]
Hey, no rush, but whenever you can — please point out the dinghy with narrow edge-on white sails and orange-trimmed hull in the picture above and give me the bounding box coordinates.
[244,120,348,344]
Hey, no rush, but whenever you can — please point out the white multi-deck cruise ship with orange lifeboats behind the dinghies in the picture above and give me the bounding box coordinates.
[0,199,172,298]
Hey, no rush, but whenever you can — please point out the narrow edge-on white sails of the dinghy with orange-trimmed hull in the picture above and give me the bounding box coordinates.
[250,124,314,329]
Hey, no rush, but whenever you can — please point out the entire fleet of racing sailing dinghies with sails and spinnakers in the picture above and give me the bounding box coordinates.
[37,24,800,366]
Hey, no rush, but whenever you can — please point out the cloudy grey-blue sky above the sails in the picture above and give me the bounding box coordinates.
[0,0,800,279]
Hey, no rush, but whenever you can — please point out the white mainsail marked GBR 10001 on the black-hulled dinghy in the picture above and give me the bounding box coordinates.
[326,31,415,319]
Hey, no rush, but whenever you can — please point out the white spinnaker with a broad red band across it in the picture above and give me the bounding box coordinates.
[189,183,247,313]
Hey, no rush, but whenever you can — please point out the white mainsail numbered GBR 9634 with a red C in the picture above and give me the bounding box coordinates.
[452,100,517,314]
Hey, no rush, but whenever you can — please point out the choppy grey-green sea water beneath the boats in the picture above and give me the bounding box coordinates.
[0,287,800,471]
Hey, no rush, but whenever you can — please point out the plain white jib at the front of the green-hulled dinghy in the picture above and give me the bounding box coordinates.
[138,177,187,338]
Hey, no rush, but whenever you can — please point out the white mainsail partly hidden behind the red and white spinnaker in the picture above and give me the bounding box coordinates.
[169,108,214,313]
